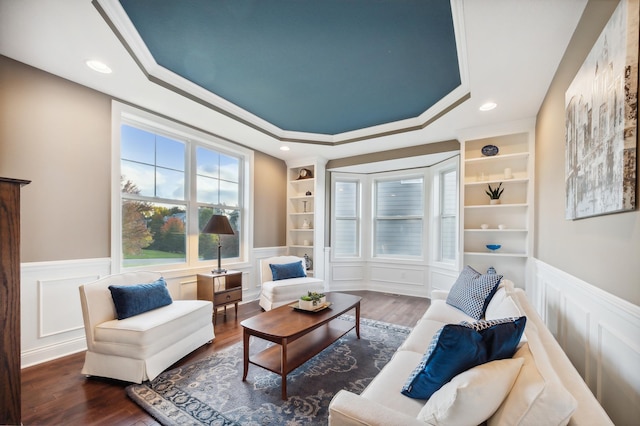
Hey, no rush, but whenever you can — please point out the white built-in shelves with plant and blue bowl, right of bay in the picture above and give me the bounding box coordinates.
[461,126,535,287]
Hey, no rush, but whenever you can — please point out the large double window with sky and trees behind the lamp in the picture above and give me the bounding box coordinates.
[118,108,245,269]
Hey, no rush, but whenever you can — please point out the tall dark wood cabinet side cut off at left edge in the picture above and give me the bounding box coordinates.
[0,177,29,425]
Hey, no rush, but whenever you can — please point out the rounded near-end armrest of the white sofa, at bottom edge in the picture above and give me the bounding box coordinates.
[329,390,424,426]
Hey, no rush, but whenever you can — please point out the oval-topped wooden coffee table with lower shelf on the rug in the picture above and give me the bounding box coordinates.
[240,293,362,400]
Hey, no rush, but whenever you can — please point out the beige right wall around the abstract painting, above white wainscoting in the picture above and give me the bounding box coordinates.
[534,0,640,305]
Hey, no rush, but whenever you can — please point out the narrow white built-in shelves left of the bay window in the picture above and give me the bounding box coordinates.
[287,160,324,278]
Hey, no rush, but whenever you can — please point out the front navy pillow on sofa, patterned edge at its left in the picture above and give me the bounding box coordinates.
[402,324,487,399]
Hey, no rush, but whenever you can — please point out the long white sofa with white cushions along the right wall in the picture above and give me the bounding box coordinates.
[329,280,613,426]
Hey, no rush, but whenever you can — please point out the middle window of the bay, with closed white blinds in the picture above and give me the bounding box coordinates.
[373,176,424,257]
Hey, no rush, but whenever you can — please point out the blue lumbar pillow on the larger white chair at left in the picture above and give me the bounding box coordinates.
[109,278,173,319]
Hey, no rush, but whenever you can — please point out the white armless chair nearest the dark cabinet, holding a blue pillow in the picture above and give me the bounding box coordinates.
[80,272,214,383]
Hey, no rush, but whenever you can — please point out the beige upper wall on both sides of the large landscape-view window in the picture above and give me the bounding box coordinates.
[0,55,286,262]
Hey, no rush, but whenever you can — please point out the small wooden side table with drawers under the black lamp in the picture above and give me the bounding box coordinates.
[198,271,242,325]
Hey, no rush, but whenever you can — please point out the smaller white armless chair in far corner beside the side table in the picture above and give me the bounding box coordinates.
[260,256,324,311]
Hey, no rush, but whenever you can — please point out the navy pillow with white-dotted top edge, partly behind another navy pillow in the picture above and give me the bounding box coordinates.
[461,316,527,362]
